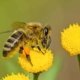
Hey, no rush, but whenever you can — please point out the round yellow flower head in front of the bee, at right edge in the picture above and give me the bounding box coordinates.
[61,24,80,55]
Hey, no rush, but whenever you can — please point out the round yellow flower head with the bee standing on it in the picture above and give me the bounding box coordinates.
[19,48,53,73]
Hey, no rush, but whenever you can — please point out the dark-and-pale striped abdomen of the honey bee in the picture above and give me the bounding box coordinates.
[3,30,23,57]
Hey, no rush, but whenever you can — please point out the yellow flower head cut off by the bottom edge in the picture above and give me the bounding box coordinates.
[2,73,29,80]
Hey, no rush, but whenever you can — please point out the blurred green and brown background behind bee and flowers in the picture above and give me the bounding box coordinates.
[0,0,80,80]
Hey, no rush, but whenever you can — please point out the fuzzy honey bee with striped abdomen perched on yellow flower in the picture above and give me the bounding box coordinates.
[0,22,51,57]
